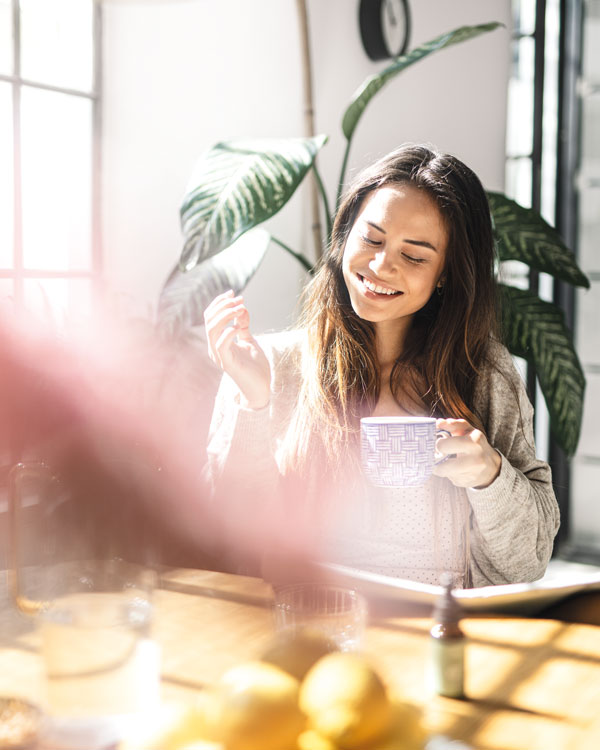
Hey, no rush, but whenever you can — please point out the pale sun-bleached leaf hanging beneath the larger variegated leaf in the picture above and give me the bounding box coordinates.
[157,229,271,338]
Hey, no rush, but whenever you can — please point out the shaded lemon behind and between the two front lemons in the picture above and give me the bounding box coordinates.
[261,627,337,681]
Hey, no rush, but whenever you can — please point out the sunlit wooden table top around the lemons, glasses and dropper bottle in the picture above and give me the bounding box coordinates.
[5,569,600,750]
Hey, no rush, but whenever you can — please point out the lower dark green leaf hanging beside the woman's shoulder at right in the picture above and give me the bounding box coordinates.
[500,284,585,456]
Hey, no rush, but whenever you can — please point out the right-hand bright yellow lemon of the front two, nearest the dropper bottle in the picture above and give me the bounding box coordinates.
[300,652,392,750]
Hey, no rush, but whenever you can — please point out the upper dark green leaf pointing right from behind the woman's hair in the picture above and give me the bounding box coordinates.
[487,192,590,289]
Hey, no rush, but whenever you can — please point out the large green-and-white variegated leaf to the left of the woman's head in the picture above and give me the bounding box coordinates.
[180,135,327,270]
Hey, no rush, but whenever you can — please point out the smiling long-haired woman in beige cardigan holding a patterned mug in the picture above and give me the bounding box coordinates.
[205,146,559,587]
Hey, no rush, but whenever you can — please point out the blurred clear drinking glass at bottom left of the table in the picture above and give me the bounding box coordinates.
[39,560,160,750]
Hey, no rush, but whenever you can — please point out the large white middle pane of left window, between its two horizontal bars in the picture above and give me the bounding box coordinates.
[21,87,92,270]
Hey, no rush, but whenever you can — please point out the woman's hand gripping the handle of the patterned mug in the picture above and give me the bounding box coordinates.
[433,419,502,489]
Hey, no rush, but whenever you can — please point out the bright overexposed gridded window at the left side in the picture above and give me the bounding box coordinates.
[0,0,101,324]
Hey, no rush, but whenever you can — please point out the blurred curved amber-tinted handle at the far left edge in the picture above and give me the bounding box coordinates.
[7,462,57,615]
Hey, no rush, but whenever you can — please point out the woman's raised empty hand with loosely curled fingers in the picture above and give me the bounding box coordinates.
[204,291,271,409]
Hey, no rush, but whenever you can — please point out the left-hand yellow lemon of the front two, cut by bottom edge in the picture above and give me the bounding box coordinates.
[218,661,306,750]
